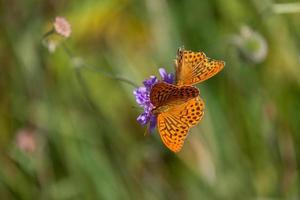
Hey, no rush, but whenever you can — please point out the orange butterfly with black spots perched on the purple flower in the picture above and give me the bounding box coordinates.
[150,48,225,153]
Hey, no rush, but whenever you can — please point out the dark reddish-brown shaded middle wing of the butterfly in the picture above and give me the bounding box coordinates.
[150,82,199,107]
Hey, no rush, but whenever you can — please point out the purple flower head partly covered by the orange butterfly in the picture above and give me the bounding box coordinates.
[133,68,174,132]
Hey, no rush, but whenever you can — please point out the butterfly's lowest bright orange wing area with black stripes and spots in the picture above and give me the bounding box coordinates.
[157,97,204,153]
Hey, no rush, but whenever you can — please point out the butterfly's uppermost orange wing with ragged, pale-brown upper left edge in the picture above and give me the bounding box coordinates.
[175,49,225,85]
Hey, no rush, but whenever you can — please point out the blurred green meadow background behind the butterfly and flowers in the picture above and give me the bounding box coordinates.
[0,0,300,200]
